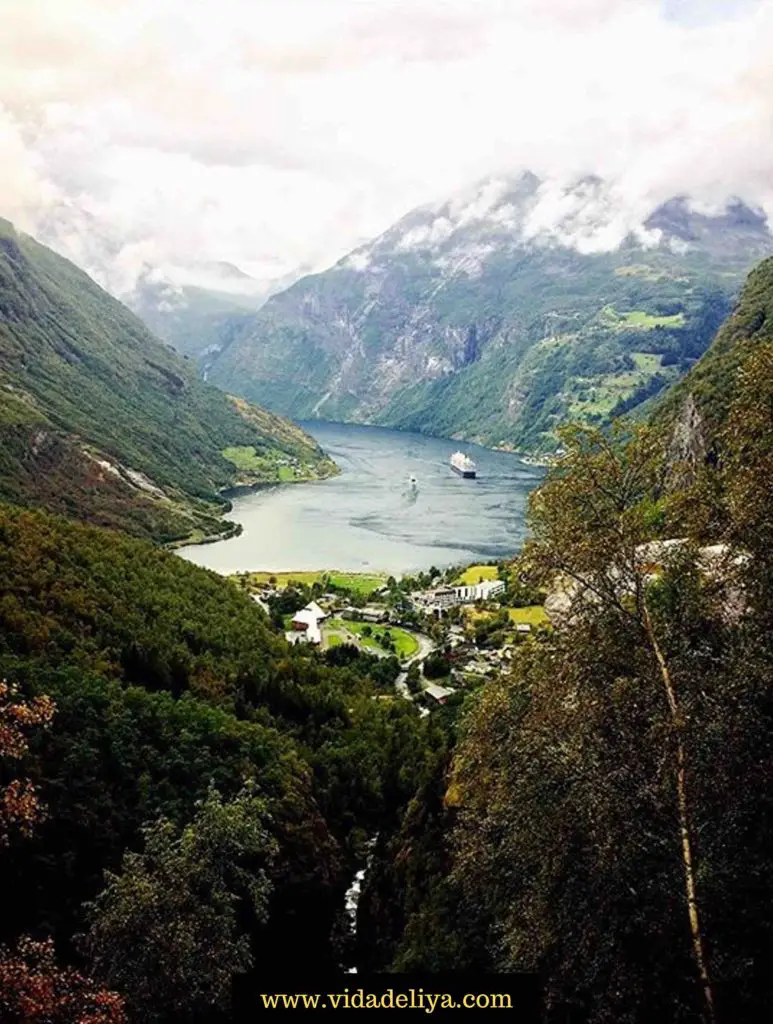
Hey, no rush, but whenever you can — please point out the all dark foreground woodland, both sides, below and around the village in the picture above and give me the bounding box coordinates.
[0,260,773,1024]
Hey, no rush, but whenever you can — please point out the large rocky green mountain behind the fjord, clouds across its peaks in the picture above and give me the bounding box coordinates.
[209,174,773,452]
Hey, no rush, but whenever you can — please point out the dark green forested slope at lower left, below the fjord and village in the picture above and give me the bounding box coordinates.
[0,507,445,1021]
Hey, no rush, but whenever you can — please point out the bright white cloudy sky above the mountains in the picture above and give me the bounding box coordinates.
[0,0,773,293]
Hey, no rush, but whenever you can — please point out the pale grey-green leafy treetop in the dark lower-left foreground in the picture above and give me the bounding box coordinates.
[85,787,276,1021]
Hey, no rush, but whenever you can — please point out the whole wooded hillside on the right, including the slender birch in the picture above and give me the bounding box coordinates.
[363,261,773,1024]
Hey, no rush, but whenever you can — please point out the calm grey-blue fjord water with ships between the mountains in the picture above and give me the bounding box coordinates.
[179,422,543,573]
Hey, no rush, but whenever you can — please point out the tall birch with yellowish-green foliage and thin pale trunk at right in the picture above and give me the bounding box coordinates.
[454,417,773,1021]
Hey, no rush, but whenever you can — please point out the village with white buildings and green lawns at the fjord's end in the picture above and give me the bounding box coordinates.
[232,563,549,714]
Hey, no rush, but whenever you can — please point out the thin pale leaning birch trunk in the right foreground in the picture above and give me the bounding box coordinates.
[642,599,717,1024]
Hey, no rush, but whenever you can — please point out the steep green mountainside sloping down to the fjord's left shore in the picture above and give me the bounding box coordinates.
[0,220,335,541]
